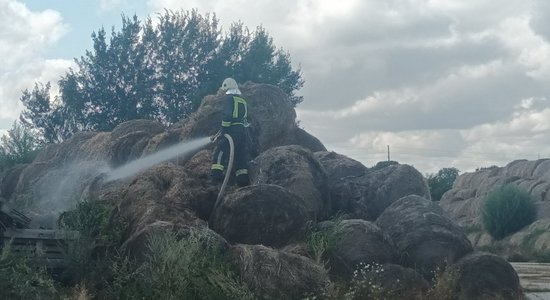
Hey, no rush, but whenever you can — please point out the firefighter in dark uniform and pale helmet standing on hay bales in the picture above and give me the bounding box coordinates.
[211,78,250,186]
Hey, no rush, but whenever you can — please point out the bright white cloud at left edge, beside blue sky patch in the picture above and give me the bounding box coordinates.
[0,0,72,125]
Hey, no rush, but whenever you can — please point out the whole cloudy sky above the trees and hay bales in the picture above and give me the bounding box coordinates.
[0,0,550,174]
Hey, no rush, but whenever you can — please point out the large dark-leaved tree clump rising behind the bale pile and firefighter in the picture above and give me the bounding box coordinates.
[20,10,304,143]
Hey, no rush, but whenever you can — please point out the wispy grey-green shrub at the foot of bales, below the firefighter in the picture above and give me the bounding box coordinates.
[101,230,253,299]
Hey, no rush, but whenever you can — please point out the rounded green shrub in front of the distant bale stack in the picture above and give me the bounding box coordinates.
[481,185,537,239]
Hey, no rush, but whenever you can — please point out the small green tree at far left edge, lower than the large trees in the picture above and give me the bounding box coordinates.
[0,121,41,170]
